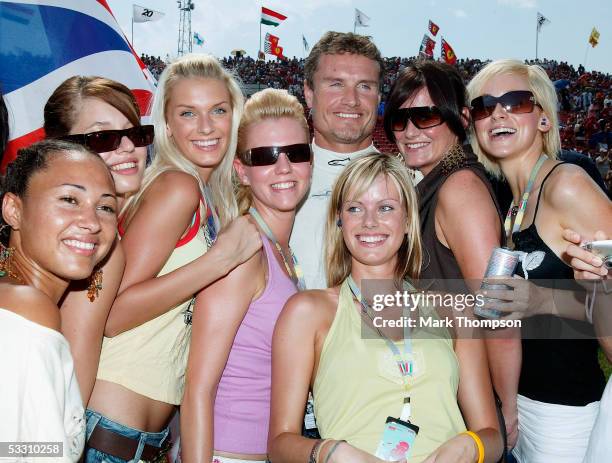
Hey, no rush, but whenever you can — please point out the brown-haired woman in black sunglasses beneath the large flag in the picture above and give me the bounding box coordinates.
[44,76,153,404]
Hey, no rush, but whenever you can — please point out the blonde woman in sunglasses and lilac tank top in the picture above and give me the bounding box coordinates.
[181,89,312,462]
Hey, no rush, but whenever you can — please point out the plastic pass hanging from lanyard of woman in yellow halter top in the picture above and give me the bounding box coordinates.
[375,399,419,461]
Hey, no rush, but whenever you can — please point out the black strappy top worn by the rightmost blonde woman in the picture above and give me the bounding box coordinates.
[512,163,605,406]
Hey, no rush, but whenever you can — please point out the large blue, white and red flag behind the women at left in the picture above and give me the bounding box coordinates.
[0,0,155,170]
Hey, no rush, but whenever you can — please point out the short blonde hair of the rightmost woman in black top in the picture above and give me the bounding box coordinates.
[467,59,561,178]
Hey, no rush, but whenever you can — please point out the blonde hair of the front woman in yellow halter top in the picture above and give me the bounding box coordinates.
[325,152,422,288]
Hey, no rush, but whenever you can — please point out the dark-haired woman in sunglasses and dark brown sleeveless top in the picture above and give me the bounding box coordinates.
[384,61,503,291]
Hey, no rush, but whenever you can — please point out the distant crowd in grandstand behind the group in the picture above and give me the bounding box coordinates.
[141,54,612,189]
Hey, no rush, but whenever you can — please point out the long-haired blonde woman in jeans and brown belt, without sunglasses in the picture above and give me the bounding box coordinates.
[85,55,261,462]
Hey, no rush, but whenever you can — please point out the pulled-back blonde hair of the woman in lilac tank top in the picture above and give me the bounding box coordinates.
[234,88,310,214]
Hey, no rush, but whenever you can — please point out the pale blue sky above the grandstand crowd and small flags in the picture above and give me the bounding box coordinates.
[108,0,612,73]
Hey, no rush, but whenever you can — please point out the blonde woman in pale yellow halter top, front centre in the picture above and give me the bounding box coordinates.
[268,153,503,463]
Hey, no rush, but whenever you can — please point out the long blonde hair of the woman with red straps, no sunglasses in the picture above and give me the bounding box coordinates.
[122,53,244,226]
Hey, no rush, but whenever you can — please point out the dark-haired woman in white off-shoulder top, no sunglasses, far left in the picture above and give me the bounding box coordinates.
[0,140,117,462]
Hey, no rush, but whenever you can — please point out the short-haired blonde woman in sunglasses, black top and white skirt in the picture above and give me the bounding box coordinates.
[468,60,612,463]
